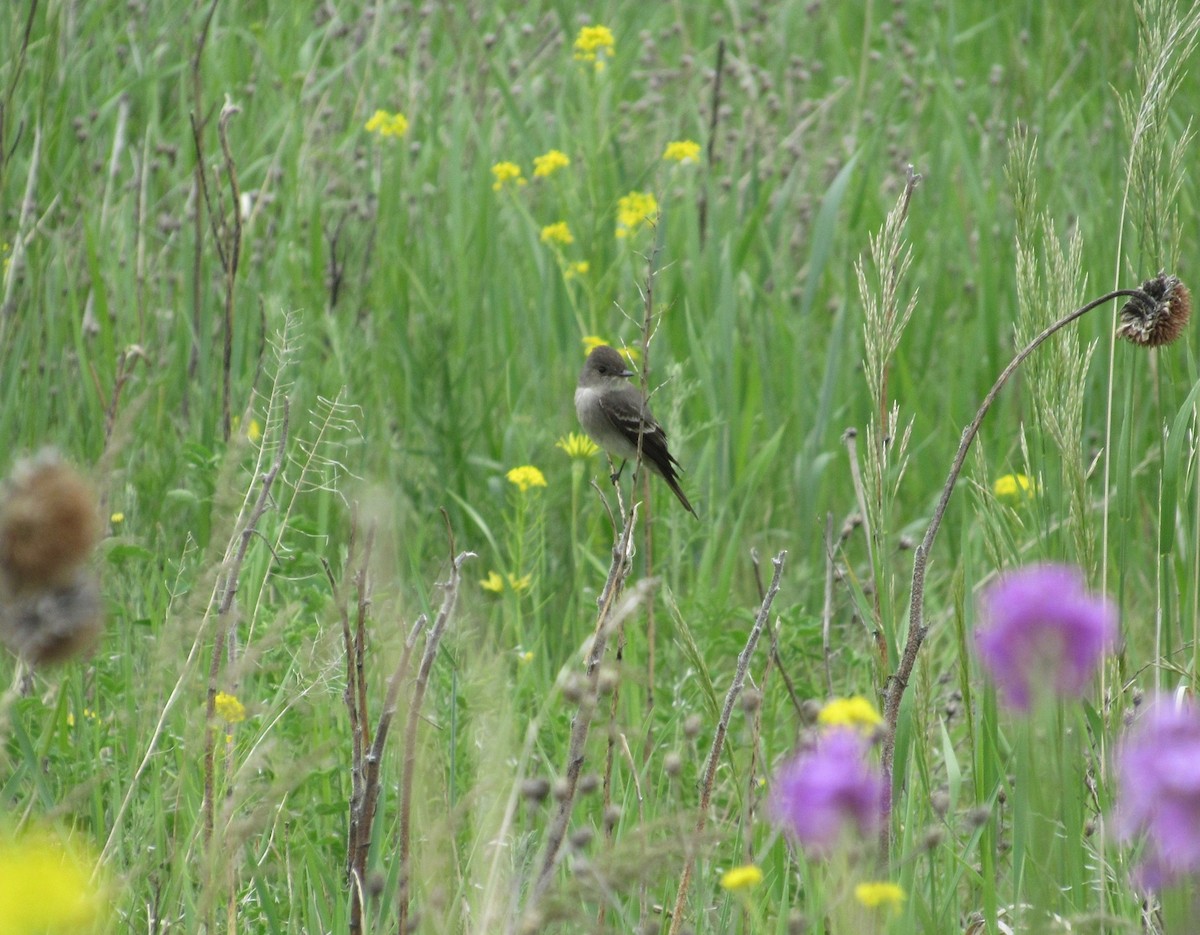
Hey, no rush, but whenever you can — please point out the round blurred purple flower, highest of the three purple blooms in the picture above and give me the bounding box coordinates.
[976,565,1117,711]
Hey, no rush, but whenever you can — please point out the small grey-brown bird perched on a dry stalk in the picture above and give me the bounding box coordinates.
[575,344,698,519]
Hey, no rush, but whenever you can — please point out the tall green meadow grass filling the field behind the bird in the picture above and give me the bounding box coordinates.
[0,0,1200,933]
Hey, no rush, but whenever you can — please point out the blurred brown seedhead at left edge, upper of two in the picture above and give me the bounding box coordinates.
[0,454,100,594]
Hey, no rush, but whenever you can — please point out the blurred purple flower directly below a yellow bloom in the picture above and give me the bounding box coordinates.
[768,727,887,855]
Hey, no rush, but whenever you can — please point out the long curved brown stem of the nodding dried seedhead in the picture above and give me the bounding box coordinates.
[883,289,1145,783]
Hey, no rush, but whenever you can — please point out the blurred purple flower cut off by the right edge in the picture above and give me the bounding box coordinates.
[1116,699,1200,889]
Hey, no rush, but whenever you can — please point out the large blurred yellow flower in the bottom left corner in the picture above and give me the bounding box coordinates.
[0,833,107,935]
